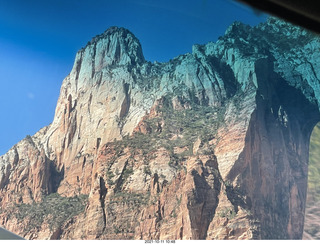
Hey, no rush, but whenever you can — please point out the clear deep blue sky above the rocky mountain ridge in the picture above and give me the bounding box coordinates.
[0,0,267,155]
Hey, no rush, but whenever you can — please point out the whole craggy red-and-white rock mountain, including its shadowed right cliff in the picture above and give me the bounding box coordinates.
[0,18,320,239]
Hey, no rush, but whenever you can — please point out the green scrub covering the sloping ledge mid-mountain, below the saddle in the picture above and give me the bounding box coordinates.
[108,95,225,173]
